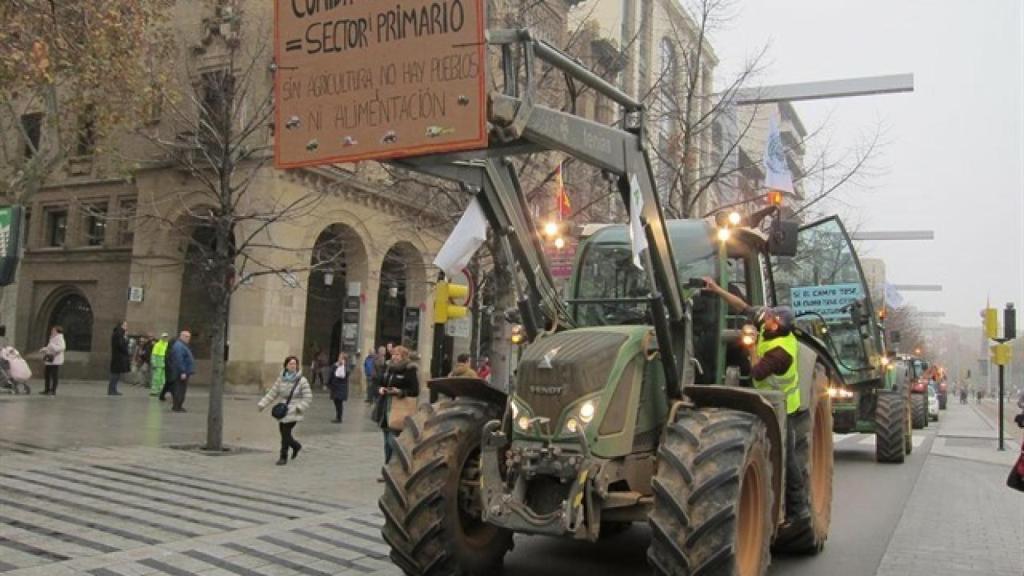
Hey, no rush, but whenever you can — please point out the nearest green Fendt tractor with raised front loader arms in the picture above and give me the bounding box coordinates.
[379,31,871,576]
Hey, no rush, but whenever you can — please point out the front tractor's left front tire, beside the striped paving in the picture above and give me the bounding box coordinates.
[379,398,512,576]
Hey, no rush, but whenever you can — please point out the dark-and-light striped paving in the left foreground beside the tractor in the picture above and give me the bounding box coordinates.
[0,434,399,576]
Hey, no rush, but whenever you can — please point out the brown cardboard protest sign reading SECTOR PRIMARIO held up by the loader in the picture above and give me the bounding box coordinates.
[274,0,487,168]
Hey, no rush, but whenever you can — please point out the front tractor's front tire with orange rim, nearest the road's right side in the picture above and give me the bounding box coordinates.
[647,409,774,576]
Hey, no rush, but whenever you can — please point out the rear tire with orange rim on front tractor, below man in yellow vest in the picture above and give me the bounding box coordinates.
[772,362,836,554]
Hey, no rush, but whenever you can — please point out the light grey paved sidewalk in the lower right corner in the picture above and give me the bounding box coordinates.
[877,403,1024,576]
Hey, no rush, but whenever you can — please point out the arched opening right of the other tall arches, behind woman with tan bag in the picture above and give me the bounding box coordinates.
[375,242,426,349]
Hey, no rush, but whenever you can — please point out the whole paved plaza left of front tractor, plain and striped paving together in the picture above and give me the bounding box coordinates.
[0,383,400,576]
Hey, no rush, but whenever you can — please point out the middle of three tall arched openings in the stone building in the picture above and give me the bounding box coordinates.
[302,223,367,366]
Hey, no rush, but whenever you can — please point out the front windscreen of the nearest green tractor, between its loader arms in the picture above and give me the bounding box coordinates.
[569,244,650,326]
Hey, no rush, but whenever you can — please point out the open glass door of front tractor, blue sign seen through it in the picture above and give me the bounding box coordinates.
[771,216,882,383]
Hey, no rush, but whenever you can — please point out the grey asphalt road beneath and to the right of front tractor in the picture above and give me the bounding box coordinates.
[506,426,935,576]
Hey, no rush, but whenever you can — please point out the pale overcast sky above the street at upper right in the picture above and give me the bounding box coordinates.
[713,0,1024,326]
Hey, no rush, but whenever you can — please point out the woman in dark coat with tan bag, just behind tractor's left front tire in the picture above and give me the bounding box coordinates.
[374,346,420,482]
